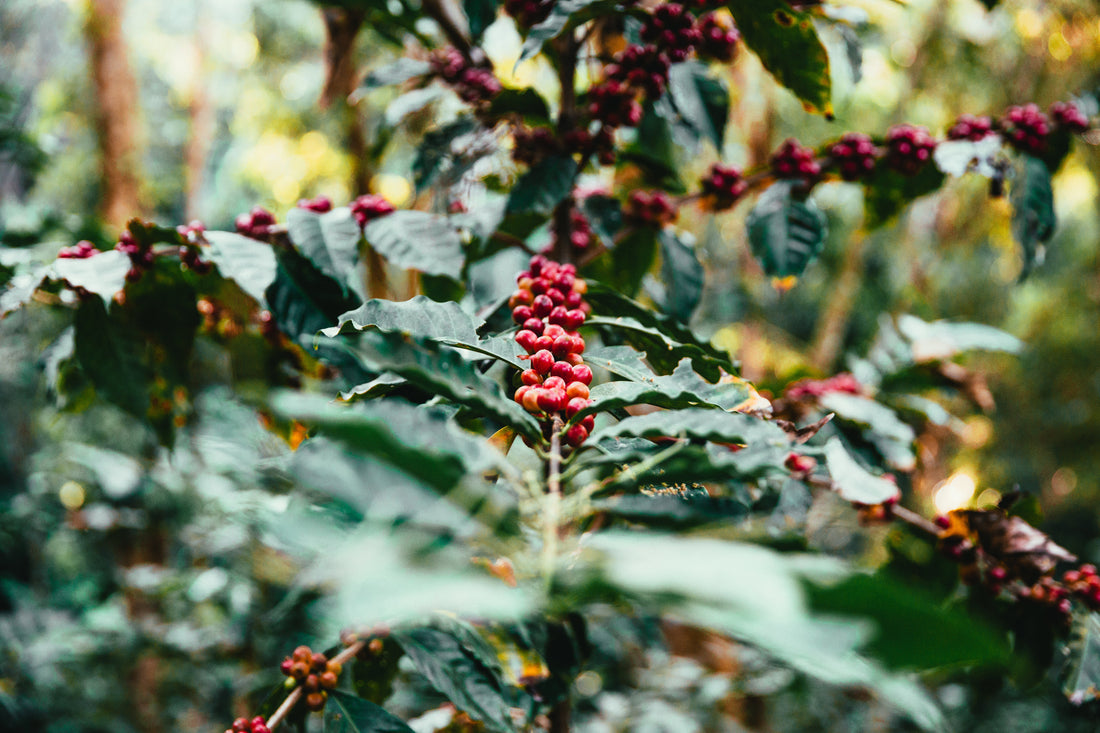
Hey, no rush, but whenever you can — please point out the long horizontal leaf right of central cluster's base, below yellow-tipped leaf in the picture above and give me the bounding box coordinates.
[592,407,790,445]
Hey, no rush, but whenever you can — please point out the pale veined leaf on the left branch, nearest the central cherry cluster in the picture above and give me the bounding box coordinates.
[365,211,465,280]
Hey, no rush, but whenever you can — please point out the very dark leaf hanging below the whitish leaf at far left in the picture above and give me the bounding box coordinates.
[73,298,150,418]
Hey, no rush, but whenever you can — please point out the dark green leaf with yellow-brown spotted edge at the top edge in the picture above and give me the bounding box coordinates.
[726,0,833,117]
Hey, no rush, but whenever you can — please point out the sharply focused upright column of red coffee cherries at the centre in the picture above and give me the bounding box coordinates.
[508,254,594,447]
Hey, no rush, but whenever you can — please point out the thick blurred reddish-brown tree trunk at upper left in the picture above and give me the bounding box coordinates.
[84,0,140,227]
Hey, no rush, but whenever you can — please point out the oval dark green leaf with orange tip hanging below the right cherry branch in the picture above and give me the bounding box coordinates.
[745,180,826,280]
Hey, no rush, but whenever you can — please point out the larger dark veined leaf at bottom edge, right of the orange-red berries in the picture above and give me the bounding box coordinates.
[393,628,515,733]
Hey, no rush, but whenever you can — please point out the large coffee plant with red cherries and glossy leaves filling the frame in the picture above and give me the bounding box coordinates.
[0,0,1100,733]
